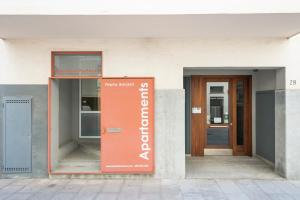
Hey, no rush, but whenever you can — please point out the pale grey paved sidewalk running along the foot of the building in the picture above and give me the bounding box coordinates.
[0,179,300,200]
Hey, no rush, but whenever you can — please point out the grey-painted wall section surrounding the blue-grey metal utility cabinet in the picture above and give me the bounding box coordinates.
[0,85,48,177]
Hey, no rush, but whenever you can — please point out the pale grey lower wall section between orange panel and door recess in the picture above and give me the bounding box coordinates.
[155,90,185,178]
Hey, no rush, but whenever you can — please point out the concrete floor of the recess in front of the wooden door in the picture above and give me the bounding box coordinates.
[186,156,281,179]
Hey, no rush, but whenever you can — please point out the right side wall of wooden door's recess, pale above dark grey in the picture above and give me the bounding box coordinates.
[253,68,285,164]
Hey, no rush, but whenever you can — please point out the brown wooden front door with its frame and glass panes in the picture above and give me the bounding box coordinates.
[191,76,252,156]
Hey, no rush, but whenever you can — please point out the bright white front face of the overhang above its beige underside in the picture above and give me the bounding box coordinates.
[0,0,300,15]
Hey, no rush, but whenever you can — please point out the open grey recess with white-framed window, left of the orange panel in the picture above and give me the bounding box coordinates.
[50,79,101,173]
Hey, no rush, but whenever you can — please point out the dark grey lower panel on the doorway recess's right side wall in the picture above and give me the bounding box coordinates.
[256,90,275,163]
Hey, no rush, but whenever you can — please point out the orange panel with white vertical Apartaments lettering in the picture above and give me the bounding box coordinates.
[101,78,154,173]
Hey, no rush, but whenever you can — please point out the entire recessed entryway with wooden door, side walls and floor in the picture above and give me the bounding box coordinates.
[184,67,285,179]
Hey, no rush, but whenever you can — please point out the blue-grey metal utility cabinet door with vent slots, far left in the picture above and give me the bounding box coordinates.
[2,96,31,173]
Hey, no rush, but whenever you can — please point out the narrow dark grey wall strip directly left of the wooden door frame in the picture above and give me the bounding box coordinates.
[183,77,191,154]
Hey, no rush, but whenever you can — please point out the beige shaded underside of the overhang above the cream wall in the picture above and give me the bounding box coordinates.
[0,13,300,38]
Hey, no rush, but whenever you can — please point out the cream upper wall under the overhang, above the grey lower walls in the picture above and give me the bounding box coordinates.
[0,38,288,89]
